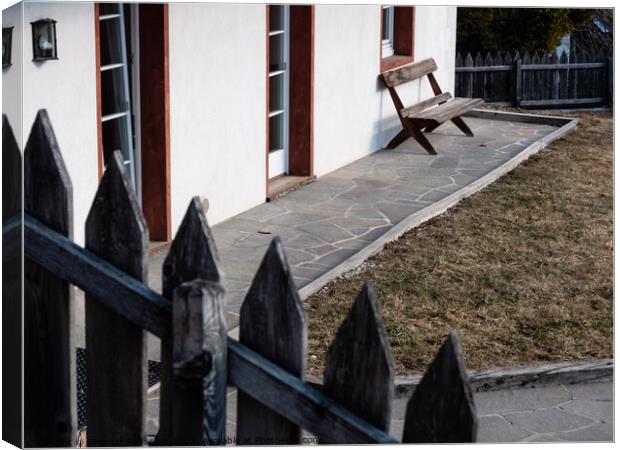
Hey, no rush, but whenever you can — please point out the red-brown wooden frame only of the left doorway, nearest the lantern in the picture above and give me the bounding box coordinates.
[94,2,172,241]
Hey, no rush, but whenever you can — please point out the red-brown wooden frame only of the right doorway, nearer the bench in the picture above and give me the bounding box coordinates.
[265,5,314,197]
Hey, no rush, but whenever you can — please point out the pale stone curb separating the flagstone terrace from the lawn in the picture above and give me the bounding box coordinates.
[299,109,578,300]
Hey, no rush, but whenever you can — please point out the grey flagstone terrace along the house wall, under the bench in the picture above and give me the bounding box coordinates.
[149,118,556,328]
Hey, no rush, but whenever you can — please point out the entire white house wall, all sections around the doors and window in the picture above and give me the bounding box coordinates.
[3,2,456,244]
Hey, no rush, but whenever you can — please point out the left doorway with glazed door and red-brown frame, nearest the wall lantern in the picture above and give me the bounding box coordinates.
[95,3,171,241]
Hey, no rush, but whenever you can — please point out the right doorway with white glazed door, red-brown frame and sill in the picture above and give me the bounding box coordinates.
[266,5,314,201]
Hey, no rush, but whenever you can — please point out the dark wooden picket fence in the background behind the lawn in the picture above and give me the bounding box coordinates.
[455,51,613,108]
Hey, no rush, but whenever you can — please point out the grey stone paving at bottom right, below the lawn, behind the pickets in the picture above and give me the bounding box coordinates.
[147,381,614,443]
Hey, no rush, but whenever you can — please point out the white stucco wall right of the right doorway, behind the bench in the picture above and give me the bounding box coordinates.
[314,5,456,176]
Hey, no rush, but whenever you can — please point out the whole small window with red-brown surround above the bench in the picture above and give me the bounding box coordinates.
[380,5,415,72]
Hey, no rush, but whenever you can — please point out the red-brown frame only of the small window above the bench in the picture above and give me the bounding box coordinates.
[379,5,415,72]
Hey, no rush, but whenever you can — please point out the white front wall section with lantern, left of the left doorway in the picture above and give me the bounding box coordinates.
[17,2,98,245]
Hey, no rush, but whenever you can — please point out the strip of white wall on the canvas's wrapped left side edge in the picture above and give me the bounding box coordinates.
[2,3,23,149]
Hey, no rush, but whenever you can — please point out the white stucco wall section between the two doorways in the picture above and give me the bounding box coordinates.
[169,4,266,232]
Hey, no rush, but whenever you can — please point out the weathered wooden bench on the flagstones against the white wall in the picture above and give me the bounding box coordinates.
[381,58,484,155]
